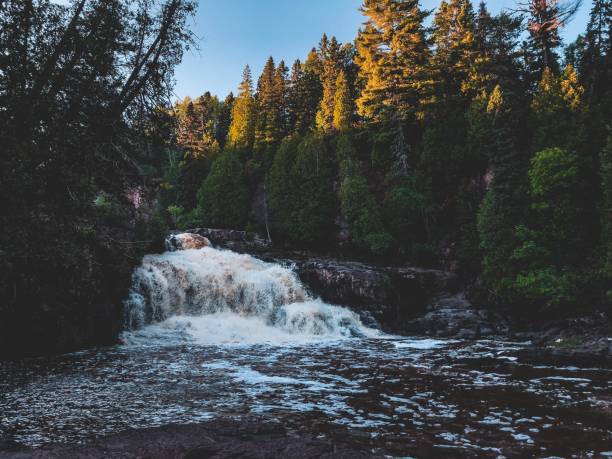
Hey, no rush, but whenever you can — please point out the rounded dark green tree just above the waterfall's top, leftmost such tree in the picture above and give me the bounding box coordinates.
[196,150,250,229]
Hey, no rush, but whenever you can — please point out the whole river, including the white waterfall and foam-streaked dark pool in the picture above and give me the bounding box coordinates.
[0,244,612,457]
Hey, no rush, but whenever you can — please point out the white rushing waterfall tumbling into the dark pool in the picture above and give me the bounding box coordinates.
[123,247,379,344]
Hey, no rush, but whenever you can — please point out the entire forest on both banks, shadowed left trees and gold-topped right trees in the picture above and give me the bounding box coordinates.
[0,0,612,360]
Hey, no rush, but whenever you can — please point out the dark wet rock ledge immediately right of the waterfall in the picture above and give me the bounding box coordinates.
[274,258,490,339]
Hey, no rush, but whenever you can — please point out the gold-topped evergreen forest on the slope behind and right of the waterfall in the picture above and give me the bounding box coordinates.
[160,0,612,315]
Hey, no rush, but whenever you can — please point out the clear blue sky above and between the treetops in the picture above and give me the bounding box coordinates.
[175,0,591,98]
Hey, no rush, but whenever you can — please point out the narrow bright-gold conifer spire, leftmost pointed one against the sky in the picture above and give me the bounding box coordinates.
[228,65,256,148]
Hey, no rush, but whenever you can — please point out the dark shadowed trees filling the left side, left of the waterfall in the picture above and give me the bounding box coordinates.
[0,0,195,360]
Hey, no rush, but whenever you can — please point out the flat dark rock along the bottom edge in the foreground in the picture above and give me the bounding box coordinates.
[0,420,384,459]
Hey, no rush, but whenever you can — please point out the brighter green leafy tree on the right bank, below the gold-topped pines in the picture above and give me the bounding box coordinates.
[513,148,589,306]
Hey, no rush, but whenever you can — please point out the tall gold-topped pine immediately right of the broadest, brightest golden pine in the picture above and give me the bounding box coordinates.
[420,0,482,225]
